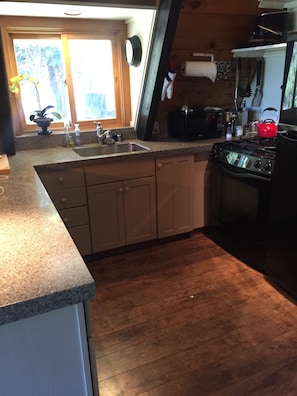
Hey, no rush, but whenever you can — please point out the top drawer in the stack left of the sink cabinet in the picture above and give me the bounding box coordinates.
[38,168,85,191]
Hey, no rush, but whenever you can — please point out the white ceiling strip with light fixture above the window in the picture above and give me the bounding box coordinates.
[0,1,151,21]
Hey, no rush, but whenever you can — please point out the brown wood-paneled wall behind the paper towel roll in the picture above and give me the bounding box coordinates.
[158,0,268,121]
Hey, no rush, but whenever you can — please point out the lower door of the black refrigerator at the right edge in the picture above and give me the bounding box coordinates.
[265,131,297,299]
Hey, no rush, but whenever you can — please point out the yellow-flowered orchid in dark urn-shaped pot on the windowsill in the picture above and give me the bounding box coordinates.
[9,74,62,135]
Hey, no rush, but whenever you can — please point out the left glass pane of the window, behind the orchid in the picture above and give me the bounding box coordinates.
[13,39,70,124]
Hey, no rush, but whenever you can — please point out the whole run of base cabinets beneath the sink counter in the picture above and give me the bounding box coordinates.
[39,152,209,255]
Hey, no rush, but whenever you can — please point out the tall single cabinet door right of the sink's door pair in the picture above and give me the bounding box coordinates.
[156,155,194,238]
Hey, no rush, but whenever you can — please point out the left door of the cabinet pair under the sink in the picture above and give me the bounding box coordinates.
[87,182,125,253]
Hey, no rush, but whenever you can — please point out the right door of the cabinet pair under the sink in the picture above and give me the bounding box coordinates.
[123,177,157,244]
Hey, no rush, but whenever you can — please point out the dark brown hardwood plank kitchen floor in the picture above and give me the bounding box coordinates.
[88,233,297,396]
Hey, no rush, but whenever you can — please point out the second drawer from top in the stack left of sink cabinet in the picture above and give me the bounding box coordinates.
[50,187,87,210]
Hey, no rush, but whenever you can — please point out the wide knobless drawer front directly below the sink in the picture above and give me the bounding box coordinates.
[85,160,155,186]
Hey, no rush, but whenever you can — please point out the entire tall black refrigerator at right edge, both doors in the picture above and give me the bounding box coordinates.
[265,33,297,300]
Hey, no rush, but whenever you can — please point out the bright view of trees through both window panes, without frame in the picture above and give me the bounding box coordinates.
[13,38,116,127]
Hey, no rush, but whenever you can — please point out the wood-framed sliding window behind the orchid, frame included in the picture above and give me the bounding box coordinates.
[3,18,131,135]
